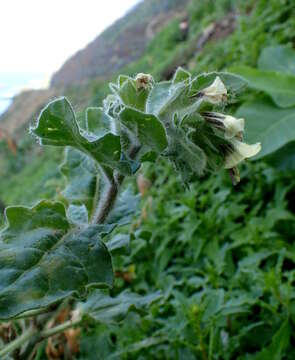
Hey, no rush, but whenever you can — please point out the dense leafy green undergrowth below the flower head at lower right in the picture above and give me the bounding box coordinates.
[82,164,295,360]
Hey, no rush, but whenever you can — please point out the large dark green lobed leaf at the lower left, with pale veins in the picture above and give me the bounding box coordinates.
[0,201,113,319]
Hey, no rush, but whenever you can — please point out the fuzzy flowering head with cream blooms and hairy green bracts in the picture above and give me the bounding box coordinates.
[97,68,261,184]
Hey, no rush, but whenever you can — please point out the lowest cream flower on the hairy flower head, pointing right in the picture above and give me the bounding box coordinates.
[224,138,261,169]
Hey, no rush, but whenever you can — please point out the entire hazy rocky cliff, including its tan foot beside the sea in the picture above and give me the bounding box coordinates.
[0,0,189,134]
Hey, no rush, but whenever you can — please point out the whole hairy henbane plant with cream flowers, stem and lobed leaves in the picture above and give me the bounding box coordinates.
[0,68,260,358]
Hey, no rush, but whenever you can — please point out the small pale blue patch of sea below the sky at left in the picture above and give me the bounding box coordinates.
[0,72,47,115]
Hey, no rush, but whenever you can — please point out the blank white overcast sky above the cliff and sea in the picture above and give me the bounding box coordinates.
[0,0,139,84]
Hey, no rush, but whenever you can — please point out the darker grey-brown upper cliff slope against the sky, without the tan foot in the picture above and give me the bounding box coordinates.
[51,0,188,87]
